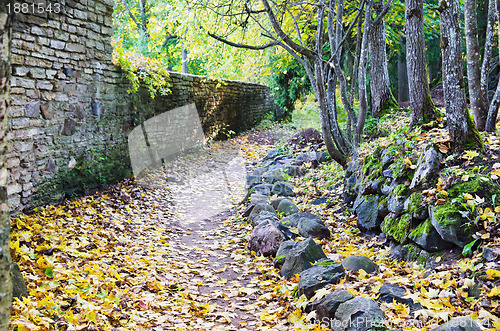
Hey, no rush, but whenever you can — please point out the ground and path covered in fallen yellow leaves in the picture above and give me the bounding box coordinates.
[6,120,500,330]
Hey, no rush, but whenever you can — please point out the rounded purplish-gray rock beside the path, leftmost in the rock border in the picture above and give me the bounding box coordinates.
[248,221,285,256]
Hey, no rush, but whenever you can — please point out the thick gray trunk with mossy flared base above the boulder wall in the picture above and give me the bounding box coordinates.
[439,0,483,150]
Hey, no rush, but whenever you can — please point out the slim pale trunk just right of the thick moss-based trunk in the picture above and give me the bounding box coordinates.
[464,0,487,131]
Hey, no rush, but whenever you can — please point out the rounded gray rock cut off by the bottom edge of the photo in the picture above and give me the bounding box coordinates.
[332,298,385,331]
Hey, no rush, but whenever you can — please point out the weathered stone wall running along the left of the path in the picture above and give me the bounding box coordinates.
[7,0,275,212]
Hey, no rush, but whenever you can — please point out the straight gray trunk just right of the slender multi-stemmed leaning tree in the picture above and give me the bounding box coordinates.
[365,1,397,116]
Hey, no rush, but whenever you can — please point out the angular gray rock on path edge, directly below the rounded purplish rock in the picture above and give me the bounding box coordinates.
[281,238,326,279]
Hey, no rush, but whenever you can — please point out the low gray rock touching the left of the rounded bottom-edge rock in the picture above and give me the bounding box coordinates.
[305,290,354,327]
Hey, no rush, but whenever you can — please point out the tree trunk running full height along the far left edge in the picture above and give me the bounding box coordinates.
[0,0,12,330]
